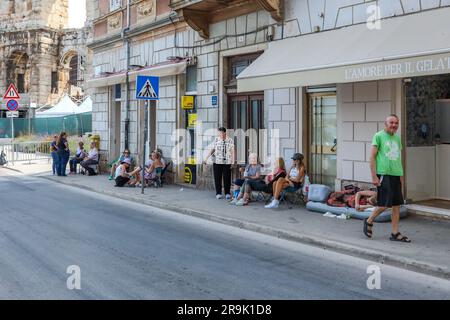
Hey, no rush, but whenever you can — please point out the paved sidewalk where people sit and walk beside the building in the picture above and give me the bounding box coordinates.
[4,161,450,279]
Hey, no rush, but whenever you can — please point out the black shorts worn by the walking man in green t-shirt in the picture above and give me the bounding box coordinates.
[377,175,403,208]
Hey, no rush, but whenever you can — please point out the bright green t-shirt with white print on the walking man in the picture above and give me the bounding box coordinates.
[372,130,403,177]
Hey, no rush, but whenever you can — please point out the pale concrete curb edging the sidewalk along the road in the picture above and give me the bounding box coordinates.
[37,176,450,280]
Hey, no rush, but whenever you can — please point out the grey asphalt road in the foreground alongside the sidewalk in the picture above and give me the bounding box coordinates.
[0,168,450,299]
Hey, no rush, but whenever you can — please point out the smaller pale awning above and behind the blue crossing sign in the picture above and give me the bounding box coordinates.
[87,60,187,88]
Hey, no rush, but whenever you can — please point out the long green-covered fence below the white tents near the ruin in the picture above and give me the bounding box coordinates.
[0,112,92,139]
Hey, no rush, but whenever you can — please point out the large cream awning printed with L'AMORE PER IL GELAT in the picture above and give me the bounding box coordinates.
[238,7,450,92]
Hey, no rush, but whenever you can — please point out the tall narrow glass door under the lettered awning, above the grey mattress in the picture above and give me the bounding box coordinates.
[308,93,337,190]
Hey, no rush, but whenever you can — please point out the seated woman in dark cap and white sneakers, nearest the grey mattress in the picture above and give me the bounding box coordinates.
[265,153,306,209]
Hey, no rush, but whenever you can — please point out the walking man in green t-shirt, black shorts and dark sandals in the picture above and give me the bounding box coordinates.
[364,114,411,242]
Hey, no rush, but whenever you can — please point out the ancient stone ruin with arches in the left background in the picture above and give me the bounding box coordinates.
[0,0,89,117]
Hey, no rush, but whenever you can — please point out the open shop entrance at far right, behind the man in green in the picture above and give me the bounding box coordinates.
[404,75,450,210]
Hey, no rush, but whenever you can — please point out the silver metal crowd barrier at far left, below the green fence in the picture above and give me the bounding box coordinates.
[0,141,51,165]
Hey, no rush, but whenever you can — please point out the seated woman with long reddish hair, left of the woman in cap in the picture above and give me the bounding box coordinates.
[236,158,286,206]
